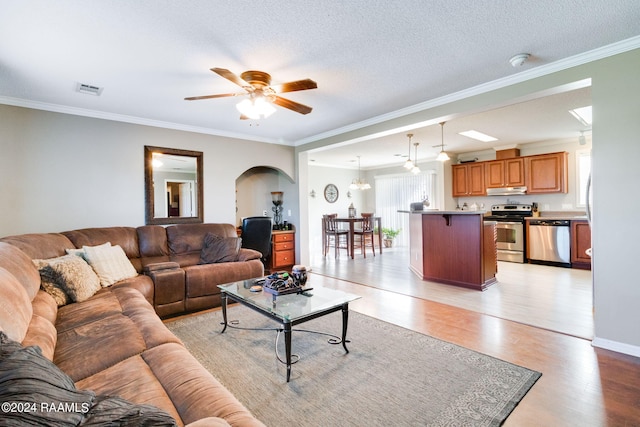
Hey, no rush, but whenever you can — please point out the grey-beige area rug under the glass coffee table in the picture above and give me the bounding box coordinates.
[167,306,541,427]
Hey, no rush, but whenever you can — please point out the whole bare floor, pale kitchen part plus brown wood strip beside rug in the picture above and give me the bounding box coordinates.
[309,248,640,426]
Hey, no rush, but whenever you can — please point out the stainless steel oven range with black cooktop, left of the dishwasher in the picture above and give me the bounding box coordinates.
[485,204,532,263]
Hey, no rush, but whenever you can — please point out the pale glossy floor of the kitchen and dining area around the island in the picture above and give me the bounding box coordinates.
[311,247,593,339]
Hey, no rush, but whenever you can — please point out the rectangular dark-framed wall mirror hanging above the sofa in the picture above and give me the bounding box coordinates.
[144,145,204,224]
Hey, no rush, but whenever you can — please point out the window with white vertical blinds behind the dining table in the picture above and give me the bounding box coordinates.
[375,170,438,246]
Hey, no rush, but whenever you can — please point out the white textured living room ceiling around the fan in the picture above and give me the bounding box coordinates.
[0,0,640,165]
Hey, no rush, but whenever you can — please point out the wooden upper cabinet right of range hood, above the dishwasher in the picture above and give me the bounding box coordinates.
[525,152,568,194]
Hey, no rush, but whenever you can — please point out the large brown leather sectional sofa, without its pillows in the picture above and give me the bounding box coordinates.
[0,224,264,426]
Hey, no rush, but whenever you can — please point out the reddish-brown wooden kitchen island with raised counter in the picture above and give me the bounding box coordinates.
[409,211,498,291]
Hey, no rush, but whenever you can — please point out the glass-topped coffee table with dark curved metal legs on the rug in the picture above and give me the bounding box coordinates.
[218,278,360,382]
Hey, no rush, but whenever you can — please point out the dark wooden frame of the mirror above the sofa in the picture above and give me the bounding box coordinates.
[144,145,204,225]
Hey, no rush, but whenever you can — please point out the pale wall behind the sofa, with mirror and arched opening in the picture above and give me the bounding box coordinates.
[0,105,295,236]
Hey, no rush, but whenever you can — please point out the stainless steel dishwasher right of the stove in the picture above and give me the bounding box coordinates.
[528,219,571,267]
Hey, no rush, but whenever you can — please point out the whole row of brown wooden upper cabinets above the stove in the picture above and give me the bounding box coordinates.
[452,152,568,197]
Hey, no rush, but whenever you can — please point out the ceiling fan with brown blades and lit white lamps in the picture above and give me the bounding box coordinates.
[185,68,318,119]
